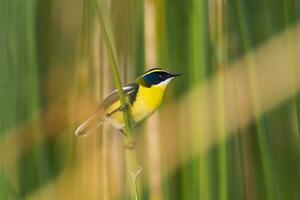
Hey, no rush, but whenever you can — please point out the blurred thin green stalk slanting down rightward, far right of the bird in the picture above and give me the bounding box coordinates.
[236,0,279,200]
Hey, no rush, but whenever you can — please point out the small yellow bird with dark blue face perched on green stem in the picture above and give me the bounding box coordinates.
[75,68,181,136]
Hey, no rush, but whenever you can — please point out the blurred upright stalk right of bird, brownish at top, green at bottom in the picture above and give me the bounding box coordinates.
[211,0,228,200]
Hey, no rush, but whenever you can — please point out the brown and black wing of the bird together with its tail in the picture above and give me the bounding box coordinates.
[75,83,139,136]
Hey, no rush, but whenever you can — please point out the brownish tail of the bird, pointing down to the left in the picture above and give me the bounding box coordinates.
[75,111,103,136]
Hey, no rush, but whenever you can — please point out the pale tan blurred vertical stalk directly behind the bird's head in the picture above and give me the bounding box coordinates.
[143,0,165,199]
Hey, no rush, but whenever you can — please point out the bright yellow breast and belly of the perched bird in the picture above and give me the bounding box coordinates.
[107,86,166,129]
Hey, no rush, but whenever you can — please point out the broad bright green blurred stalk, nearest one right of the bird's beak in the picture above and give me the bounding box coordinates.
[190,0,211,199]
